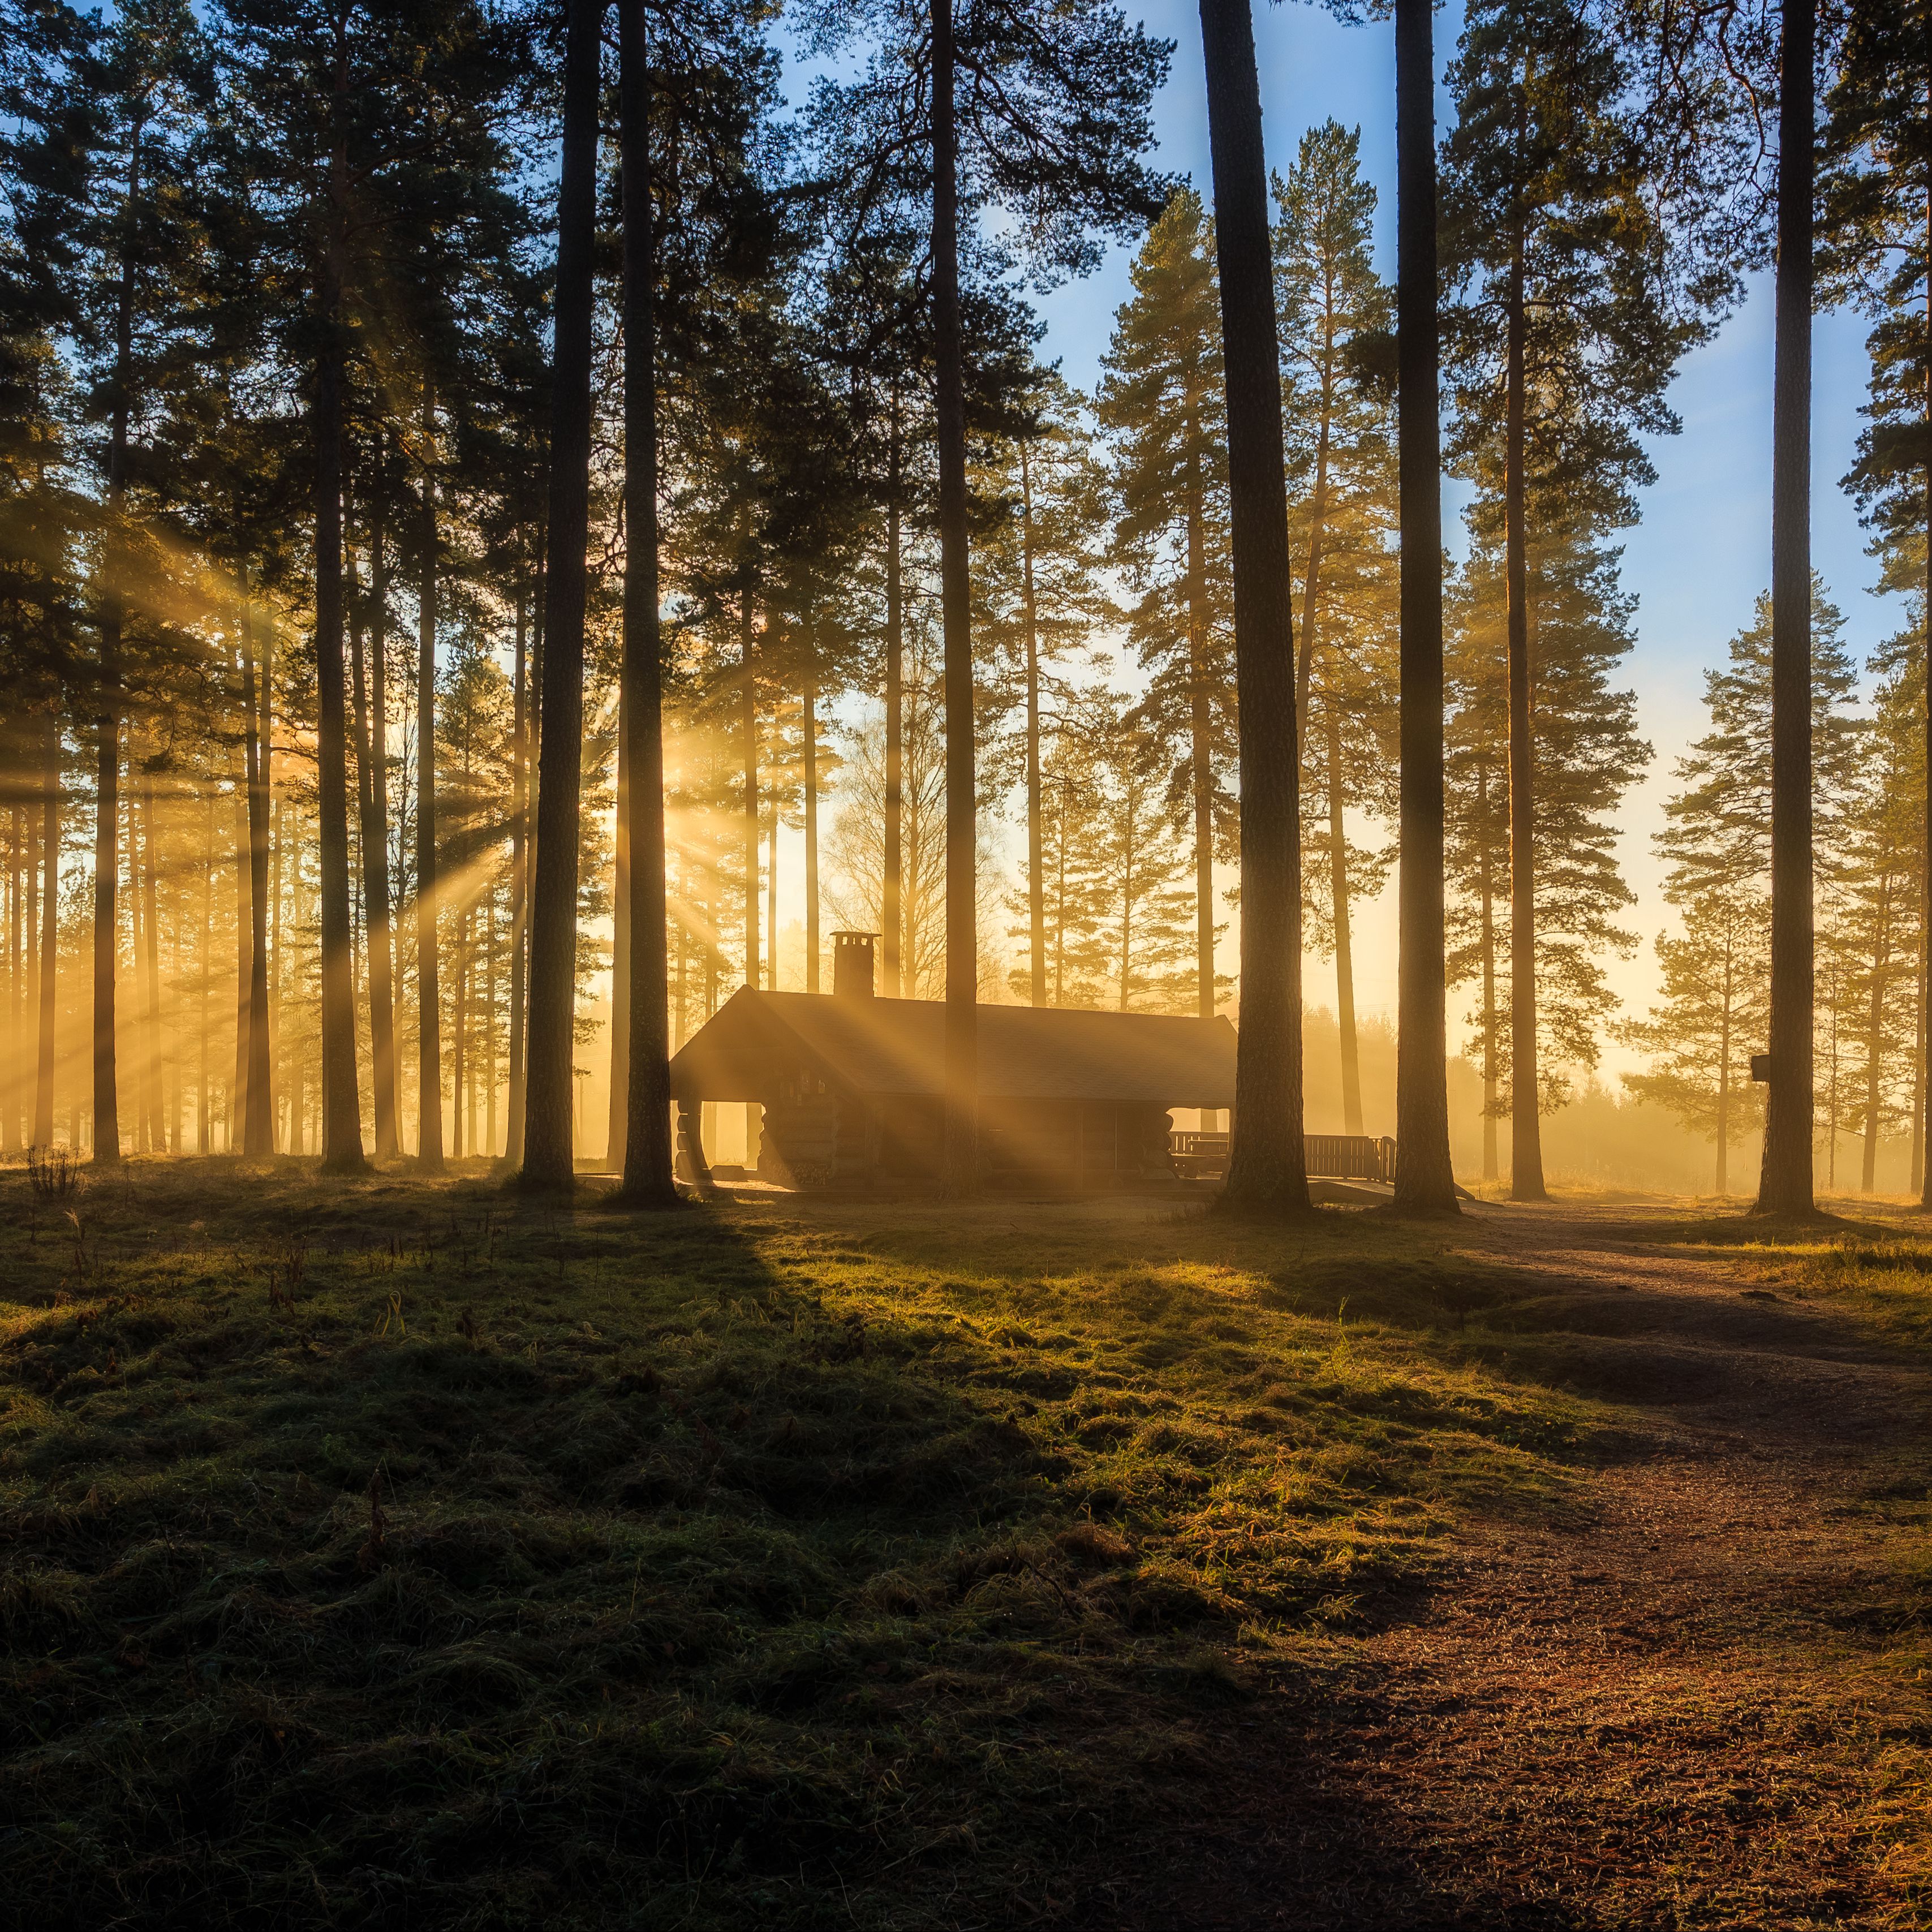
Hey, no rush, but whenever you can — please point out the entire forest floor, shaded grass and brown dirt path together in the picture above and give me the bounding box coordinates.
[0,1161,1932,1932]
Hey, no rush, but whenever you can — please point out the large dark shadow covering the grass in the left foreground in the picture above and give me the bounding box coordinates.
[0,1169,1070,1926]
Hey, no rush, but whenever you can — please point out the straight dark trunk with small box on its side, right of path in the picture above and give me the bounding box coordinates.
[1756,0,1816,1215]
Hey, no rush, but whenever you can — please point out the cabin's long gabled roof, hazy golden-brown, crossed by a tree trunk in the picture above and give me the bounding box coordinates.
[670,987,1234,1107]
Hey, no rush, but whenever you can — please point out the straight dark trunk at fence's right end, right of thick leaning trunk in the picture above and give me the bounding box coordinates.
[1395,0,1458,1215]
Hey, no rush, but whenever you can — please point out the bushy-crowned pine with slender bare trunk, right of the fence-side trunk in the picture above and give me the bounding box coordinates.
[1443,0,1702,1200]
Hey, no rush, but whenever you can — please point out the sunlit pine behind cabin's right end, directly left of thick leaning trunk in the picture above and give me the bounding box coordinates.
[1095,190,1234,1018]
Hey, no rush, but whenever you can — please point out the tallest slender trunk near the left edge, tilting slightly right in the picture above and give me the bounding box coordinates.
[93,120,143,1167]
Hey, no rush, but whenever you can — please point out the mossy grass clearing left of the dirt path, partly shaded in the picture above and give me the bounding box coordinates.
[0,1161,1594,1928]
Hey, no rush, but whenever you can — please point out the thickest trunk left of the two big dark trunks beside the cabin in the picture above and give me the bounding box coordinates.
[315,10,363,1173]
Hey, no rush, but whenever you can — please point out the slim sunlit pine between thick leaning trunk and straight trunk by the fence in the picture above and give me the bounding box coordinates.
[1273,120,1399,1134]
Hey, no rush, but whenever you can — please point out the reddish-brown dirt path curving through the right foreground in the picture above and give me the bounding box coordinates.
[1082,1207,1932,1932]
